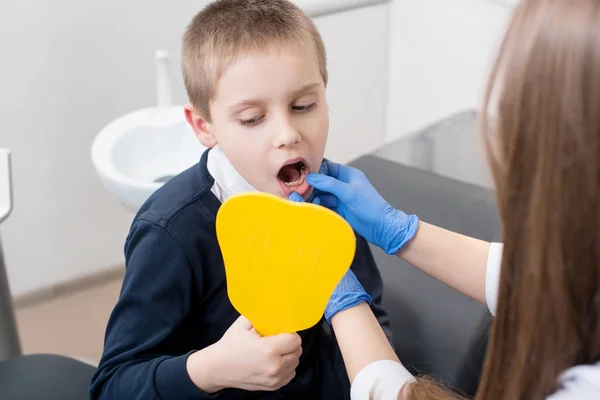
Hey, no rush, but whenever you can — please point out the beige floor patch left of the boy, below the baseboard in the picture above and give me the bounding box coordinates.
[16,280,121,364]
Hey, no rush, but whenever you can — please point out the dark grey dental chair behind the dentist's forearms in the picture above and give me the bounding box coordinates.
[351,155,500,395]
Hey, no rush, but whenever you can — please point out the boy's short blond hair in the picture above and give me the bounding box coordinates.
[182,0,327,121]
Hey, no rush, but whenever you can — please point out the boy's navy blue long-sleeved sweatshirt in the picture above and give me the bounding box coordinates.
[90,152,391,400]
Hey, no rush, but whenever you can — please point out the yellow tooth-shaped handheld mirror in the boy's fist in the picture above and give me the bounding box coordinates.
[216,193,356,336]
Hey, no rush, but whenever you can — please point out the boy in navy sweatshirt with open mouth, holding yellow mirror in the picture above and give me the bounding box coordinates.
[90,0,388,400]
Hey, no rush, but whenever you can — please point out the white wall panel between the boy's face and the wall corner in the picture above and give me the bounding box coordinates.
[315,3,389,163]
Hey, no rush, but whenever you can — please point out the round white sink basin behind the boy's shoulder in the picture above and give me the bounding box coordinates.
[92,106,206,212]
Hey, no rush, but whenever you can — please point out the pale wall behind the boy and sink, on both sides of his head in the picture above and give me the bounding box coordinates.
[0,0,388,295]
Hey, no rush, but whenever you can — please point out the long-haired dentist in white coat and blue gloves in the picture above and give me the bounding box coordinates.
[291,0,600,400]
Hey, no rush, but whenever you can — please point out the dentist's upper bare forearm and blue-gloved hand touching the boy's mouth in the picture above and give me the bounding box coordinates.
[307,161,490,303]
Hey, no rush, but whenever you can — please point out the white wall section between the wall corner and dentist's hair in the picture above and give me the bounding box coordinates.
[386,0,514,141]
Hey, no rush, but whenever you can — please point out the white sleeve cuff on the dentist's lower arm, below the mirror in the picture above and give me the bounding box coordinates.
[350,360,415,400]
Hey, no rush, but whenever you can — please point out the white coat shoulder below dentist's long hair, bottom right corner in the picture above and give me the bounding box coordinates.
[546,363,600,400]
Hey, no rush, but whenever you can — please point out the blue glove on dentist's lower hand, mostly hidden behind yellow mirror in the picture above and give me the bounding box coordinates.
[289,192,371,324]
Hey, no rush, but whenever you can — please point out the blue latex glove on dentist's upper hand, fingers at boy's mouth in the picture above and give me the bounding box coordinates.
[298,161,419,254]
